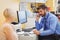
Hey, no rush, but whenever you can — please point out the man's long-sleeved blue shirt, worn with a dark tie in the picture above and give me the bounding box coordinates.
[35,12,58,36]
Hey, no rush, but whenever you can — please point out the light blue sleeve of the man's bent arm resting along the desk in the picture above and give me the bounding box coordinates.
[40,17,58,36]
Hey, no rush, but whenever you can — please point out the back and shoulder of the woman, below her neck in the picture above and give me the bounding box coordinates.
[2,23,18,40]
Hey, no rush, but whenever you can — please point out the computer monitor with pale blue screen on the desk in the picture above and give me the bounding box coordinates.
[17,11,27,24]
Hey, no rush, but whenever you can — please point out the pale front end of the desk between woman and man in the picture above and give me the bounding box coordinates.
[17,32,37,40]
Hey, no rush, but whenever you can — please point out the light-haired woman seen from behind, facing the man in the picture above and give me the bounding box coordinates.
[1,9,18,40]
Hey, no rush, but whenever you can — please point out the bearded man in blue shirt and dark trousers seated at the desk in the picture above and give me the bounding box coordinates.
[33,5,58,40]
